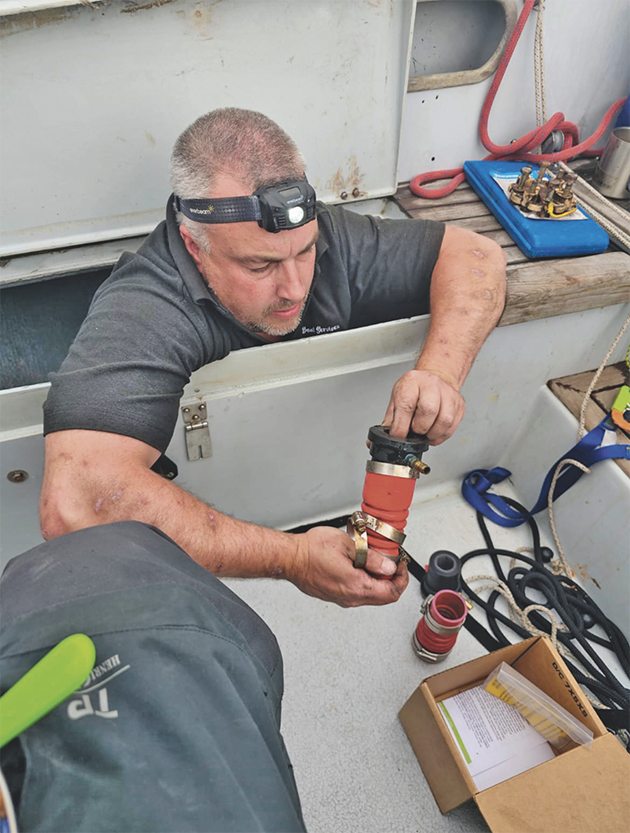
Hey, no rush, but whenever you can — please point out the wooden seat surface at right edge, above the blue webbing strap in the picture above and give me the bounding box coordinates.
[548,362,630,477]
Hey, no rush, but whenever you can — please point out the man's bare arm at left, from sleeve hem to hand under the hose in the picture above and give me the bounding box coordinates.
[40,429,408,607]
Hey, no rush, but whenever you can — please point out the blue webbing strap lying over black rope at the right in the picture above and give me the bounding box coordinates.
[462,416,630,527]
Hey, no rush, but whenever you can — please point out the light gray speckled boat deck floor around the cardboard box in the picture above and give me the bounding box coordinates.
[228,474,628,833]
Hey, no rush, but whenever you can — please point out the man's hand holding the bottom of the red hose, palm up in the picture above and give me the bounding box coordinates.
[286,526,409,607]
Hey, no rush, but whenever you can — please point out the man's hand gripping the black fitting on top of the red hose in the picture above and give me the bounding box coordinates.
[383,370,466,445]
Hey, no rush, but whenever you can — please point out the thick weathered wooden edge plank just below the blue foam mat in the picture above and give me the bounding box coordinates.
[499,252,630,326]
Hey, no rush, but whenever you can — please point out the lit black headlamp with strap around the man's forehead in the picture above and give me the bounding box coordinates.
[175,177,315,234]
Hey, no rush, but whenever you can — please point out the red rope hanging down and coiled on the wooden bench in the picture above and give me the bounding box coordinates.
[409,0,626,200]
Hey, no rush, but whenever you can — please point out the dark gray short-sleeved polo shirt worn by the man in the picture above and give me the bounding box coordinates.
[44,199,444,452]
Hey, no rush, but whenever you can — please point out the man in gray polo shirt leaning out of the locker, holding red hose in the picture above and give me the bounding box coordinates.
[41,108,505,606]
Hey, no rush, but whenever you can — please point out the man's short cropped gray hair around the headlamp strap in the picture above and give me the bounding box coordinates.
[171,107,305,251]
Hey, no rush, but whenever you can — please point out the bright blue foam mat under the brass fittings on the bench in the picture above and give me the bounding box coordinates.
[464,162,610,257]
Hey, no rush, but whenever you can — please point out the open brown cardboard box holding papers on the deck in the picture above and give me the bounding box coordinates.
[399,637,630,833]
